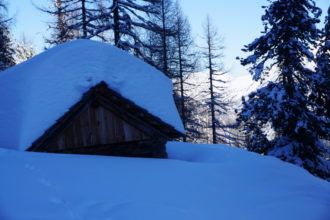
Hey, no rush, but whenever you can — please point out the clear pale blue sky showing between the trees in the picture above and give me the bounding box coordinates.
[7,0,329,76]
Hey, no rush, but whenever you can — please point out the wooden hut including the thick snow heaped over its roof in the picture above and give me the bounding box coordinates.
[0,40,184,158]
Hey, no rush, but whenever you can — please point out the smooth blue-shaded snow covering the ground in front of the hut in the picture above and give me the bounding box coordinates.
[0,142,330,220]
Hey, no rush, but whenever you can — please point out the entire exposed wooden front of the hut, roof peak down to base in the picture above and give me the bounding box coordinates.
[28,82,183,157]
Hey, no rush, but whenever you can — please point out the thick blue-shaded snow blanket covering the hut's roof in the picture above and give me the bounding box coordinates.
[0,40,184,150]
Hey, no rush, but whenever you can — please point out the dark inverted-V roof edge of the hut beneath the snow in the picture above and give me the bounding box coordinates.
[27,82,183,152]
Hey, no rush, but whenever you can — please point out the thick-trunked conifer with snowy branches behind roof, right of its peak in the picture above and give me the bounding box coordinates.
[96,0,160,59]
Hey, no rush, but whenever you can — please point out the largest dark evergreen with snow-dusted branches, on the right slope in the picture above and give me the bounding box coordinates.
[238,0,330,178]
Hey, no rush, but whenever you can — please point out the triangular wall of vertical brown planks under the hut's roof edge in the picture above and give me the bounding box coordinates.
[47,105,150,150]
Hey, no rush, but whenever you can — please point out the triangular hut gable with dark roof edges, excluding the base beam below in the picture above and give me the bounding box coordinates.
[28,83,180,157]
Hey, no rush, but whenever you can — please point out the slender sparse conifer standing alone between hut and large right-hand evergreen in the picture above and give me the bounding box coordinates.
[202,17,228,144]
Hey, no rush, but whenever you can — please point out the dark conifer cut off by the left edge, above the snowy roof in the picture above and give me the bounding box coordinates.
[0,0,15,71]
